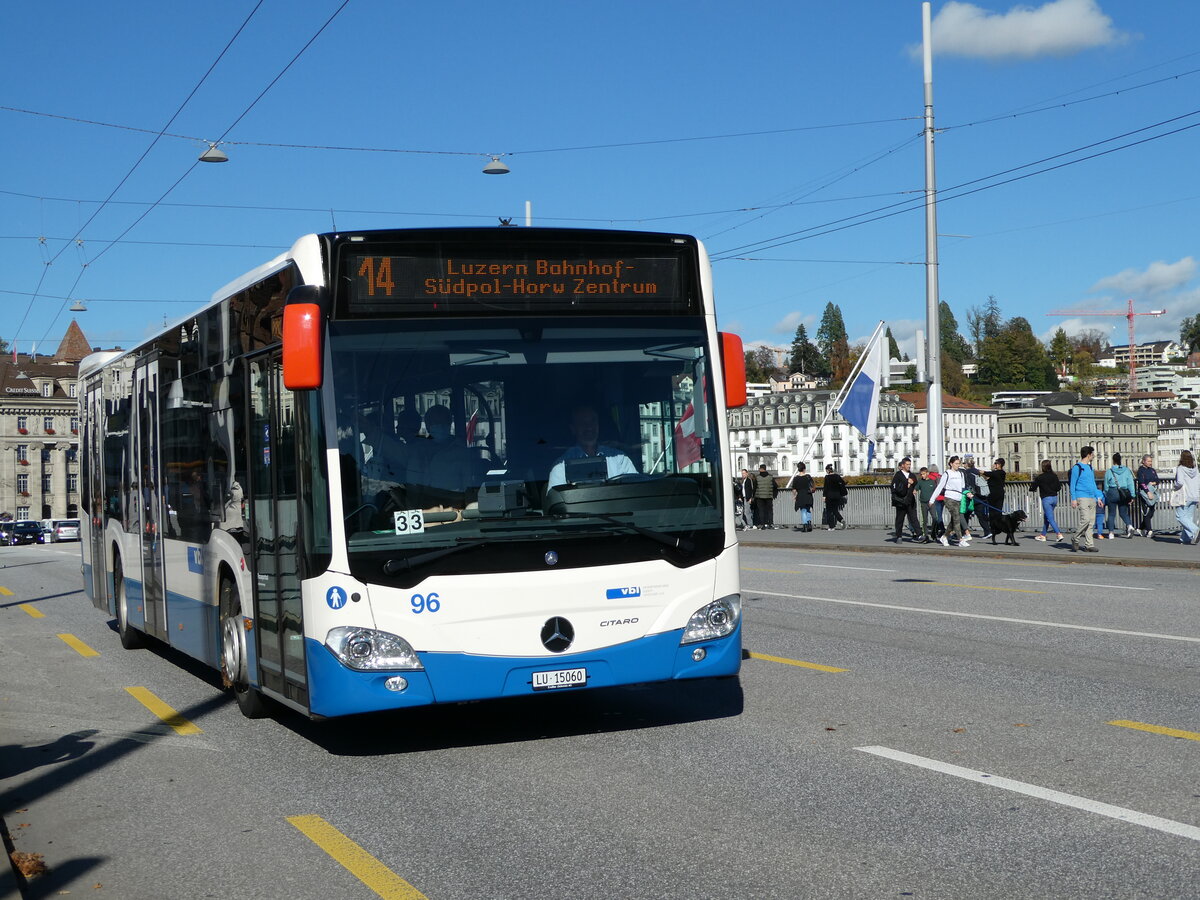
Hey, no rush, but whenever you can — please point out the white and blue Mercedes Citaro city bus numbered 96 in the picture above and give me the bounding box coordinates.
[80,227,745,719]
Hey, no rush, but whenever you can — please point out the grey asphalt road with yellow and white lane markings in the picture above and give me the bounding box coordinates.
[0,545,1200,900]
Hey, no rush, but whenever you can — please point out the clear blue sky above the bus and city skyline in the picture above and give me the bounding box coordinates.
[0,0,1200,362]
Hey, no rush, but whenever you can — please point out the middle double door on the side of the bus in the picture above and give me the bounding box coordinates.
[130,358,167,640]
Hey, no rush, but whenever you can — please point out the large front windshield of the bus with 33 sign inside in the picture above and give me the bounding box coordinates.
[329,316,724,581]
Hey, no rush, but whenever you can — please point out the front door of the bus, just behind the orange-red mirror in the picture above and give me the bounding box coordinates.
[246,350,308,710]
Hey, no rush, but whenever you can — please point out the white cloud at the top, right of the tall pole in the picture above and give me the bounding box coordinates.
[916,0,1129,60]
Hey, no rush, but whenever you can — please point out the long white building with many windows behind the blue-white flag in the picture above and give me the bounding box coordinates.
[728,390,920,475]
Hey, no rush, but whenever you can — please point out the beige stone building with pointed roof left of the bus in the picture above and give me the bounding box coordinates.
[0,322,91,522]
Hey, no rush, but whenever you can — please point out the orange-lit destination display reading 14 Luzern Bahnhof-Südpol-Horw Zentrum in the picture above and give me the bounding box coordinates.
[346,254,680,314]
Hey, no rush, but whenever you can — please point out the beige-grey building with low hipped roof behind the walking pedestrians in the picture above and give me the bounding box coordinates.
[997,391,1158,473]
